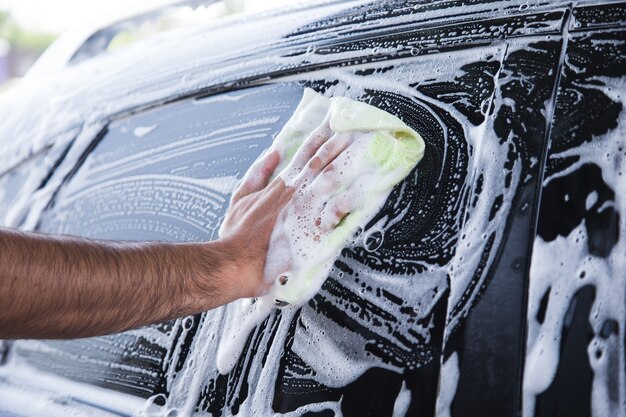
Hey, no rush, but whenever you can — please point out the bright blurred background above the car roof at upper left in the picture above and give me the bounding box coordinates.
[0,0,294,88]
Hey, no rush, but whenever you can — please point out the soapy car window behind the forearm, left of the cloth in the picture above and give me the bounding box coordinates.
[15,84,301,397]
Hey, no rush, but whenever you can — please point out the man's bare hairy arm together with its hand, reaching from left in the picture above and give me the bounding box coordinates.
[0,145,308,339]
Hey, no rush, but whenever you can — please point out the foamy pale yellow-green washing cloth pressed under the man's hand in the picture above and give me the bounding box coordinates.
[233,89,425,305]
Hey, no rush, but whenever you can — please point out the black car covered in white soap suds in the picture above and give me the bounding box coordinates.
[0,0,626,417]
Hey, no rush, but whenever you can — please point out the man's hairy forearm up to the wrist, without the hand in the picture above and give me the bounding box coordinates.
[0,230,236,338]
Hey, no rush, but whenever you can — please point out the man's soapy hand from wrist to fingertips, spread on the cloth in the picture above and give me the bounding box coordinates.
[206,125,334,299]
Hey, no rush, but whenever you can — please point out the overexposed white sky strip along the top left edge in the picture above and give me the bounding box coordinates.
[0,0,296,34]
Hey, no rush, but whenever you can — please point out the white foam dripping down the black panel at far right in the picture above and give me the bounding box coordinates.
[523,74,626,417]
